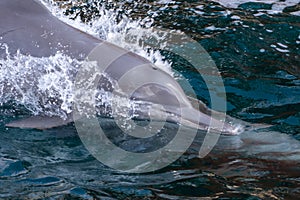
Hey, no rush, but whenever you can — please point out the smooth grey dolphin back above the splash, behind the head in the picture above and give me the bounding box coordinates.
[0,0,102,59]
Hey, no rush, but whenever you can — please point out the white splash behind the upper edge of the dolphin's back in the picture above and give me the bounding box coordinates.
[41,0,174,76]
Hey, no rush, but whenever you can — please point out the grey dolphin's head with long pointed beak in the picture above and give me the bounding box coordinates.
[108,63,241,134]
